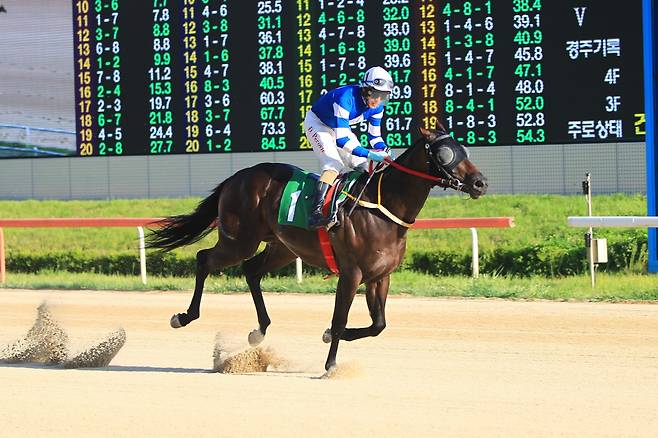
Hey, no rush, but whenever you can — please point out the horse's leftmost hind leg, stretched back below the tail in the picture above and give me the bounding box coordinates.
[171,238,260,328]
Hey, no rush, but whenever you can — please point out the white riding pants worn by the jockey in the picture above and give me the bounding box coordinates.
[304,110,368,173]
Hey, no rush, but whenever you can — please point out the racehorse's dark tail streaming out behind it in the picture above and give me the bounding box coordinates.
[146,182,224,252]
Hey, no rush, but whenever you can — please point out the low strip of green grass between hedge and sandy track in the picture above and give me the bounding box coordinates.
[4,272,658,301]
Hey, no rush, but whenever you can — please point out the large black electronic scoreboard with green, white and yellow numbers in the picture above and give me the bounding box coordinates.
[72,0,645,156]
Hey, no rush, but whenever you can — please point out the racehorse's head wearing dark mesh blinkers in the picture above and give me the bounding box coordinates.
[420,126,488,199]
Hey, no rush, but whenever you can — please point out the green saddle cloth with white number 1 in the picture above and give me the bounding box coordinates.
[279,169,362,230]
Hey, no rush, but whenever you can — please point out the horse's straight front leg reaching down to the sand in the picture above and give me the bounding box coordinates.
[324,268,361,370]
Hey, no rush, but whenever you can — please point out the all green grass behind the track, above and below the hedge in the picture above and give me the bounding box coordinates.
[0,195,658,301]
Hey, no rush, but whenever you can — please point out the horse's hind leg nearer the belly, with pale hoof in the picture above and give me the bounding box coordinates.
[242,242,296,347]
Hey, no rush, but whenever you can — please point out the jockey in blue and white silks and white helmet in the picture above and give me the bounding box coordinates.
[304,67,394,229]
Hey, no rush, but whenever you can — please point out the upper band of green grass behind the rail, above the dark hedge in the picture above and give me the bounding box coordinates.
[0,195,647,256]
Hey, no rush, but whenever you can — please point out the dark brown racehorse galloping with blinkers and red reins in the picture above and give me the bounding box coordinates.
[147,126,487,370]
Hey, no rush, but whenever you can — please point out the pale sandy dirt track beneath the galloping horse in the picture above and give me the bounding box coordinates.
[0,290,658,437]
